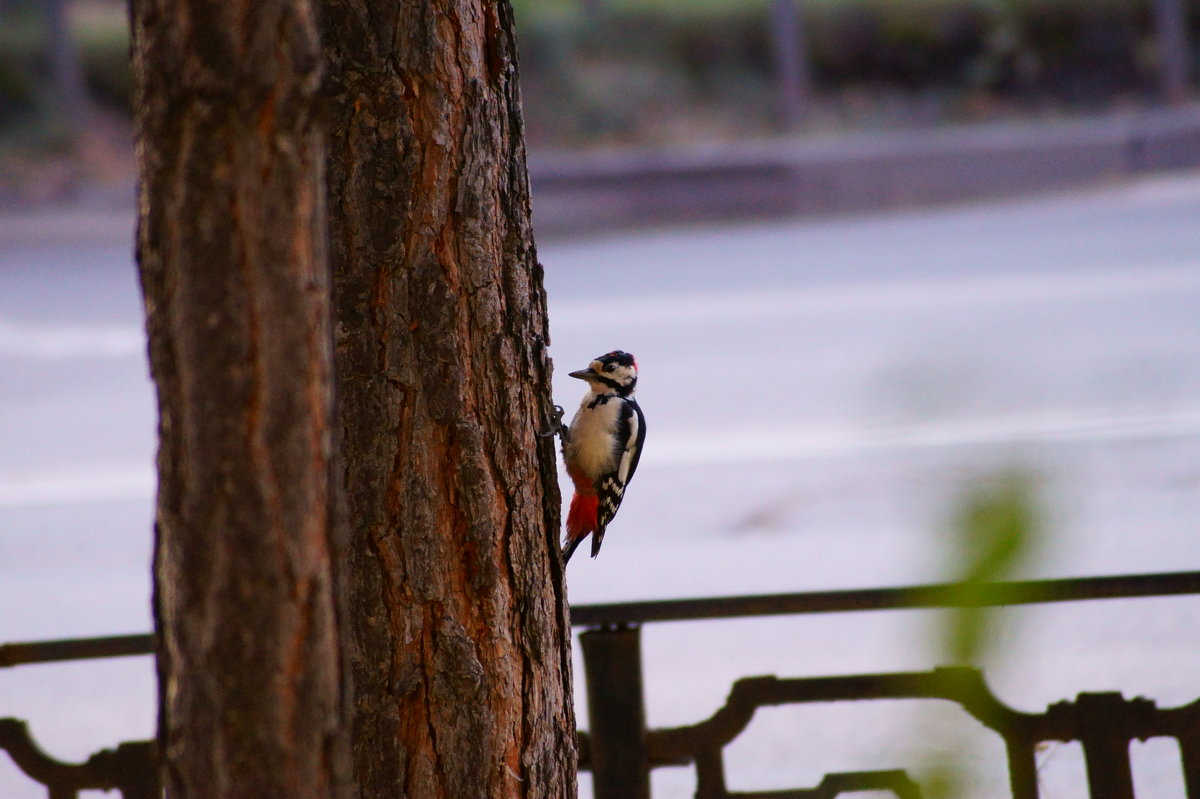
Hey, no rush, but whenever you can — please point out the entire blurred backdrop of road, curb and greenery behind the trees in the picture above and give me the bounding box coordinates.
[0,0,1200,799]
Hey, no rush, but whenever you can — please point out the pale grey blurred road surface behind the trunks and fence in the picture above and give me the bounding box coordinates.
[0,174,1200,799]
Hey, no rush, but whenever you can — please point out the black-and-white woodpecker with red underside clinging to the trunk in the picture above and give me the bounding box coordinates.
[563,349,646,565]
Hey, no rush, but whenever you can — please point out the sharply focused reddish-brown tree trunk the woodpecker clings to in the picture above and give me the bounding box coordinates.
[323,0,575,799]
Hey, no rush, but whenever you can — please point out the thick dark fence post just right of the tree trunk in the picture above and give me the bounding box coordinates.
[580,626,650,799]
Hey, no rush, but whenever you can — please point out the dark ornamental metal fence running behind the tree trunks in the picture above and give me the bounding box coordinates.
[0,571,1200,799]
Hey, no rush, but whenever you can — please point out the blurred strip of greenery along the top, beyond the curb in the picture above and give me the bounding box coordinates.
[7,0,1200,206]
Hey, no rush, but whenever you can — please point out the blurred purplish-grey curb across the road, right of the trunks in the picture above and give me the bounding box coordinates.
[529,104,1200,235]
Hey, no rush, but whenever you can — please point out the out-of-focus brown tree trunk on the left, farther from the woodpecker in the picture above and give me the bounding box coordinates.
[133,0,349,799]
